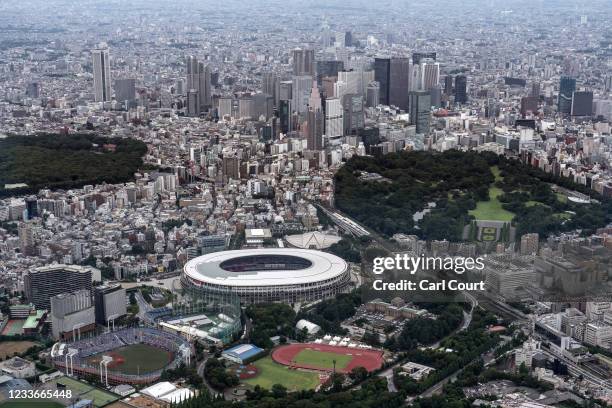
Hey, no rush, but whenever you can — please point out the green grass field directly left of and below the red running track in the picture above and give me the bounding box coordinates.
[243,356,319,391]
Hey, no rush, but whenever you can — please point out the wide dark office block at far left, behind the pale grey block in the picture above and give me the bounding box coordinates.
[23,265,94,310]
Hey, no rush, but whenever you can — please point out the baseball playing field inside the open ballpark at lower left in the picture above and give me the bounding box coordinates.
[88,344,173,374]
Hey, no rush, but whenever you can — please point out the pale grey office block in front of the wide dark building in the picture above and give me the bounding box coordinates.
[49,289,95,340]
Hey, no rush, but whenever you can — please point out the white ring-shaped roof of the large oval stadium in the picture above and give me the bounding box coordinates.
[184,248,348,286]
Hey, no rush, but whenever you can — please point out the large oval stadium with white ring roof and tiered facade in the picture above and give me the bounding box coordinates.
[182,248,351,304]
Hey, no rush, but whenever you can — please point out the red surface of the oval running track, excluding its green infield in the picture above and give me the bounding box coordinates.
[272,343,383,373]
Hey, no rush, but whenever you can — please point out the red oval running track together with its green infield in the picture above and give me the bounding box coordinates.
[272,343,383,373]
